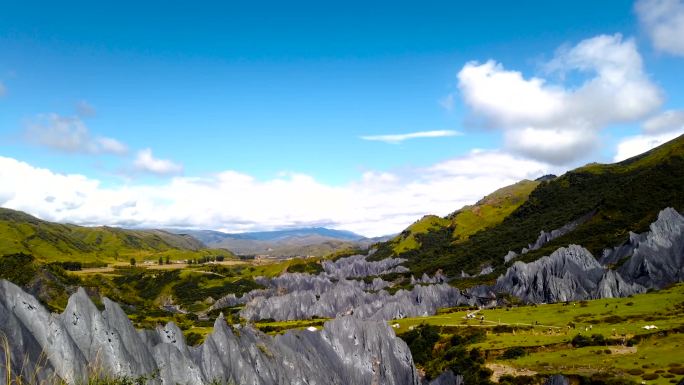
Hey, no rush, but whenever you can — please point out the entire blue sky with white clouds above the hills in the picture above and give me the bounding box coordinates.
[0,0,684,235]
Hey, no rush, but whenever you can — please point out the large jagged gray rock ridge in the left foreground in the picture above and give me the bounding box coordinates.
[0,281,419,385]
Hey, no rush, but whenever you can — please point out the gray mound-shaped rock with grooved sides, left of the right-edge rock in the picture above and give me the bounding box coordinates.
[495,245,645,303]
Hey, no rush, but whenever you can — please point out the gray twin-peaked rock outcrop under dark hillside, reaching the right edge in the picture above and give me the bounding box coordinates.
[494,208,684,302]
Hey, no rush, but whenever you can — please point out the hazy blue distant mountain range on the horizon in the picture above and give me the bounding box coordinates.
[168,227,392,257]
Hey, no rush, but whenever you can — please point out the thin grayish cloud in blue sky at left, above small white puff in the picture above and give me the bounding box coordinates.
[24,114,128,155]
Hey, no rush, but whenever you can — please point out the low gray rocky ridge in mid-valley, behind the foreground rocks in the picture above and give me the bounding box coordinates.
[211,255,477,321]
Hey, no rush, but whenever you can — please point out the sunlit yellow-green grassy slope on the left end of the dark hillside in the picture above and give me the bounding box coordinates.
[387,180,539,254]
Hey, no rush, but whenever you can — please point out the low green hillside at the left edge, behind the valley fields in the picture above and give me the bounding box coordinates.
[0,208,232,263]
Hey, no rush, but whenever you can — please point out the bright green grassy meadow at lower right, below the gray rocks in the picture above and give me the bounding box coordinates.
[391,284,684,384]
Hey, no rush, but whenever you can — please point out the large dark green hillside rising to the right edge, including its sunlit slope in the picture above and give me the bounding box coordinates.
[373,136,684,276]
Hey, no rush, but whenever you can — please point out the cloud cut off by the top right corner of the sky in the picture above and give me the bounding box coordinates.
[635,0,684,56]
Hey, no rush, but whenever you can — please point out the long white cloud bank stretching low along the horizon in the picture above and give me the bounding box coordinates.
[0,151,556,236]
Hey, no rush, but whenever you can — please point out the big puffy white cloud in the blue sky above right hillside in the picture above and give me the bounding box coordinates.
[458,34,662,165]
